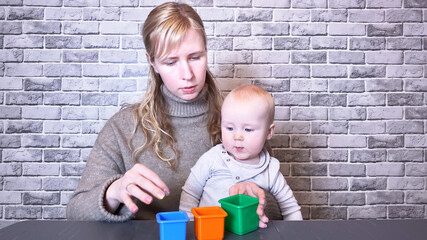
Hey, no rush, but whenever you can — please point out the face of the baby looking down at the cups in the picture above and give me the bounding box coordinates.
[221,96,271,164]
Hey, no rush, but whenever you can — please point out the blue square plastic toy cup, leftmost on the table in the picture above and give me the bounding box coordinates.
[156,211,190,240]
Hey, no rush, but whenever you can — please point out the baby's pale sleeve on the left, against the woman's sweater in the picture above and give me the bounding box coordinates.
[179,151,212,220]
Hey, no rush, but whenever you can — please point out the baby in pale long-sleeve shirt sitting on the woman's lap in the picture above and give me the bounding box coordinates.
[179,85,302,220]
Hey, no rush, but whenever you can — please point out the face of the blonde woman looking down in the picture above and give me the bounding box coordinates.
[150,29,207,100]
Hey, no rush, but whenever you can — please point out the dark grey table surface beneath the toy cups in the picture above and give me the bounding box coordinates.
[0,219,427,240]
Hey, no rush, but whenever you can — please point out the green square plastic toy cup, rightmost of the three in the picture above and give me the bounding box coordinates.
[218,194,259,235]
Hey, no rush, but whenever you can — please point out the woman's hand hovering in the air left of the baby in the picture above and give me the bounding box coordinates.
[105,163,170,213]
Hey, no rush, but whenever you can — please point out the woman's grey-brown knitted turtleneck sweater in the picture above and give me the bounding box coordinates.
[67,86,212,221]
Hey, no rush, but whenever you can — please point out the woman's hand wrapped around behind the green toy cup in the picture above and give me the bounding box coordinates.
[229,182,268,228]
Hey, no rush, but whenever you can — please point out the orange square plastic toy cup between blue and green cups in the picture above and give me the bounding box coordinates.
[191,207,227,240]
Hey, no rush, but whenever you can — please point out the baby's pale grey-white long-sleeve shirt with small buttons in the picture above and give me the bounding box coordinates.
[179,144,302,220]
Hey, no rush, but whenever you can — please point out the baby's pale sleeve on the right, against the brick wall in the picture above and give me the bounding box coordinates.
[269,158,302,220]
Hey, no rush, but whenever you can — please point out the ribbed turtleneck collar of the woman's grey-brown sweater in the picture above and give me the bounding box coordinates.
[161,84,208,117]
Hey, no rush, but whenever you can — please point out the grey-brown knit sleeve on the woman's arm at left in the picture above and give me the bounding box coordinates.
[67,119,133,222]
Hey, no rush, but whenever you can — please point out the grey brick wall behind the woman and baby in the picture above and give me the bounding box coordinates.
[0,0,427,228]
